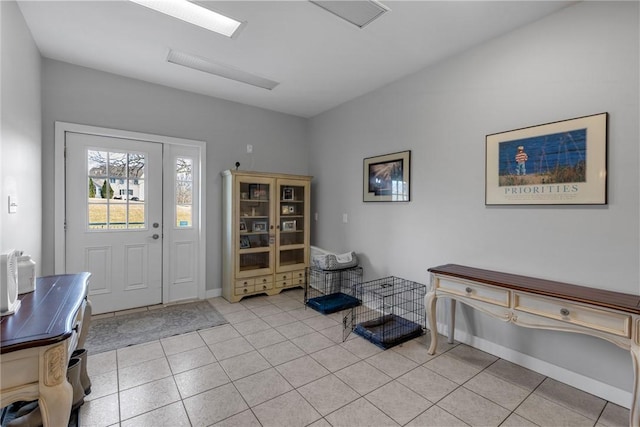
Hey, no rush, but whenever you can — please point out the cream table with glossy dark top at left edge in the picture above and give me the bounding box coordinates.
[0,273,91,427]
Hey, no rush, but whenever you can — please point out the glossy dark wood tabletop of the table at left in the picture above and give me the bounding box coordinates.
[0,273,91,354]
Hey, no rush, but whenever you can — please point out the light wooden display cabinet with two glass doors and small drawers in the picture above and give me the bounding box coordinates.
[222,170,311,302]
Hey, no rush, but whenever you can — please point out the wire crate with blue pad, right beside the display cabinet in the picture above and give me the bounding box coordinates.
[304,267,362,314]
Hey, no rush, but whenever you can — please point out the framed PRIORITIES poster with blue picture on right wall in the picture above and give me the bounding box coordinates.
[485,113,608,205]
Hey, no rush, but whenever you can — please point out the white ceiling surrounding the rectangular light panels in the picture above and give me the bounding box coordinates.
[18,0,575,117]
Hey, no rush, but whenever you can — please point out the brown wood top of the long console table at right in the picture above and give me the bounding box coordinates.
[428,264,640,314]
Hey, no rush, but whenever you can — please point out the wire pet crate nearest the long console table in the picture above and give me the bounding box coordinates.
[344,276,427,349]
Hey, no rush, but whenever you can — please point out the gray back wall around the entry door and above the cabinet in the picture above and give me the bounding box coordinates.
[42,59,308,290]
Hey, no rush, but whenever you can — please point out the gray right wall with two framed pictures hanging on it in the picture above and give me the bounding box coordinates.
[310,2,640,398]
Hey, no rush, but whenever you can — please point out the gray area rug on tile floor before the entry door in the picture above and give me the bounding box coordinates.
[85,301,227,354]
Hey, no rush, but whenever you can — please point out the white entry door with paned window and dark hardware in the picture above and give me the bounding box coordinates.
[65,132,163,314]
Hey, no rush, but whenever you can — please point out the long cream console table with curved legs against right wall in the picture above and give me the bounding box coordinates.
[425,264,640,426]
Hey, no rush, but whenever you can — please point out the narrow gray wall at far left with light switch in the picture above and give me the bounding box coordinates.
[0,1,42,274]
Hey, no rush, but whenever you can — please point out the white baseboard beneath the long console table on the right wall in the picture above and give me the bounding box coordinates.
[438,323,632,409]
